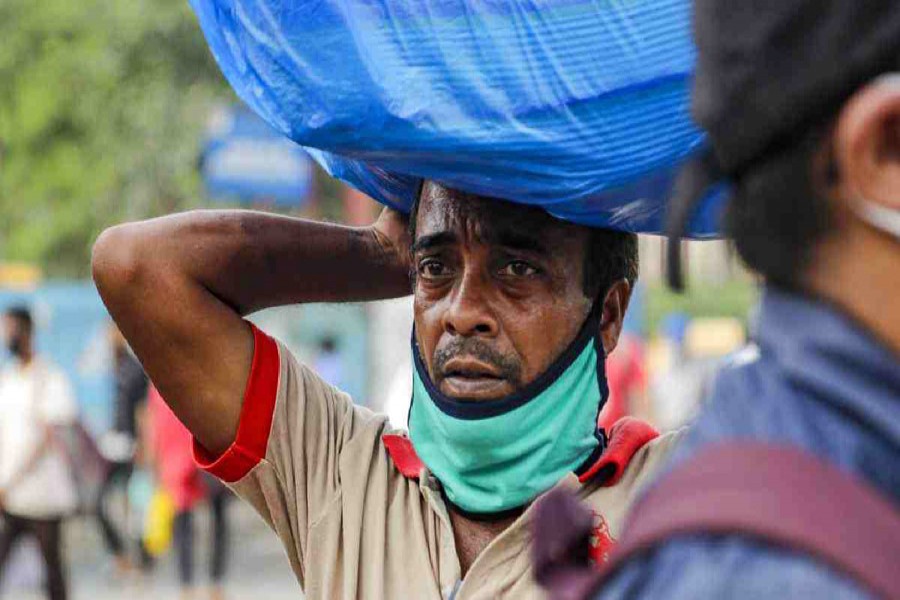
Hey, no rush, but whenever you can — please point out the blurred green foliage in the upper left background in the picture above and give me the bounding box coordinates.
[0,0,232,276]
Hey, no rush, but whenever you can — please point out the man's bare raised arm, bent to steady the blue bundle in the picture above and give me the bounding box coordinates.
[93,210,410,454]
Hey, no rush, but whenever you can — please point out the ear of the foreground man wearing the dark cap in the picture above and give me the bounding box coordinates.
[834,74,900,217]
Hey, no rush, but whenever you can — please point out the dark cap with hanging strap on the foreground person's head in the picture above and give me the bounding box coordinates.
[668,0,900,287]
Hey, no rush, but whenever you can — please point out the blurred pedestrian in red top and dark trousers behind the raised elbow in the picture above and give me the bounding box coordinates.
[147,386,230,600]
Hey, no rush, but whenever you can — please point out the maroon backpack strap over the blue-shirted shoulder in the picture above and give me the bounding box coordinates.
[594,442,900,598]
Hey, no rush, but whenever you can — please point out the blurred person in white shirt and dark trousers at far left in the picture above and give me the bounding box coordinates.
[0,307,78,600]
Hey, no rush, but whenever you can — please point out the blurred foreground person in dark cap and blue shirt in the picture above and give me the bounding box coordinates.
[536,0,900,600]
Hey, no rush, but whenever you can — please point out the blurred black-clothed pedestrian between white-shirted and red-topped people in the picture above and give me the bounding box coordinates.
[96,324,148,573]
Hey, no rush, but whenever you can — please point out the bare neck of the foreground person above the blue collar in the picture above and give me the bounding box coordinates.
[807,224,900,357]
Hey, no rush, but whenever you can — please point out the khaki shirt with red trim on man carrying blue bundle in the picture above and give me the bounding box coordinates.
[195,329,675,600]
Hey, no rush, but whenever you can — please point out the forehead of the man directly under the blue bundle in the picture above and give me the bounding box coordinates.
[416,183,574,245]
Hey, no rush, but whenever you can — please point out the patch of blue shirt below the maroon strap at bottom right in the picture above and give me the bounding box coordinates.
[595,536,874,600]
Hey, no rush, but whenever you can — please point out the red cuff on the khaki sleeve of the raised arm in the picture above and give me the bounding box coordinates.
[194,323,281,483]
